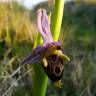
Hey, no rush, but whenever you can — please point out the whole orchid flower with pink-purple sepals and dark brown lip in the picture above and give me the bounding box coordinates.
[22,9,70,81]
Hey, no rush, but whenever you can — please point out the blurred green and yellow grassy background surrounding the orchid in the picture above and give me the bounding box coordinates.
[0,0,96,96]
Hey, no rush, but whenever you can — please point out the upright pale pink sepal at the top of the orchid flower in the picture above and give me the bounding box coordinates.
[37,9,53,45]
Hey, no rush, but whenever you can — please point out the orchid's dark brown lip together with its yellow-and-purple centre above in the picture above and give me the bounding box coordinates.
[42,42,68,81]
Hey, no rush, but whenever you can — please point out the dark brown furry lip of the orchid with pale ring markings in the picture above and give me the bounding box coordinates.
[43,54,64,81]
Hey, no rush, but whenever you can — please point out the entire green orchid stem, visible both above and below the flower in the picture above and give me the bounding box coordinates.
[33,0,64,96]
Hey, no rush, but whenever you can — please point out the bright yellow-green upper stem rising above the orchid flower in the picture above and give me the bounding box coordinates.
[51,0,64,41]
